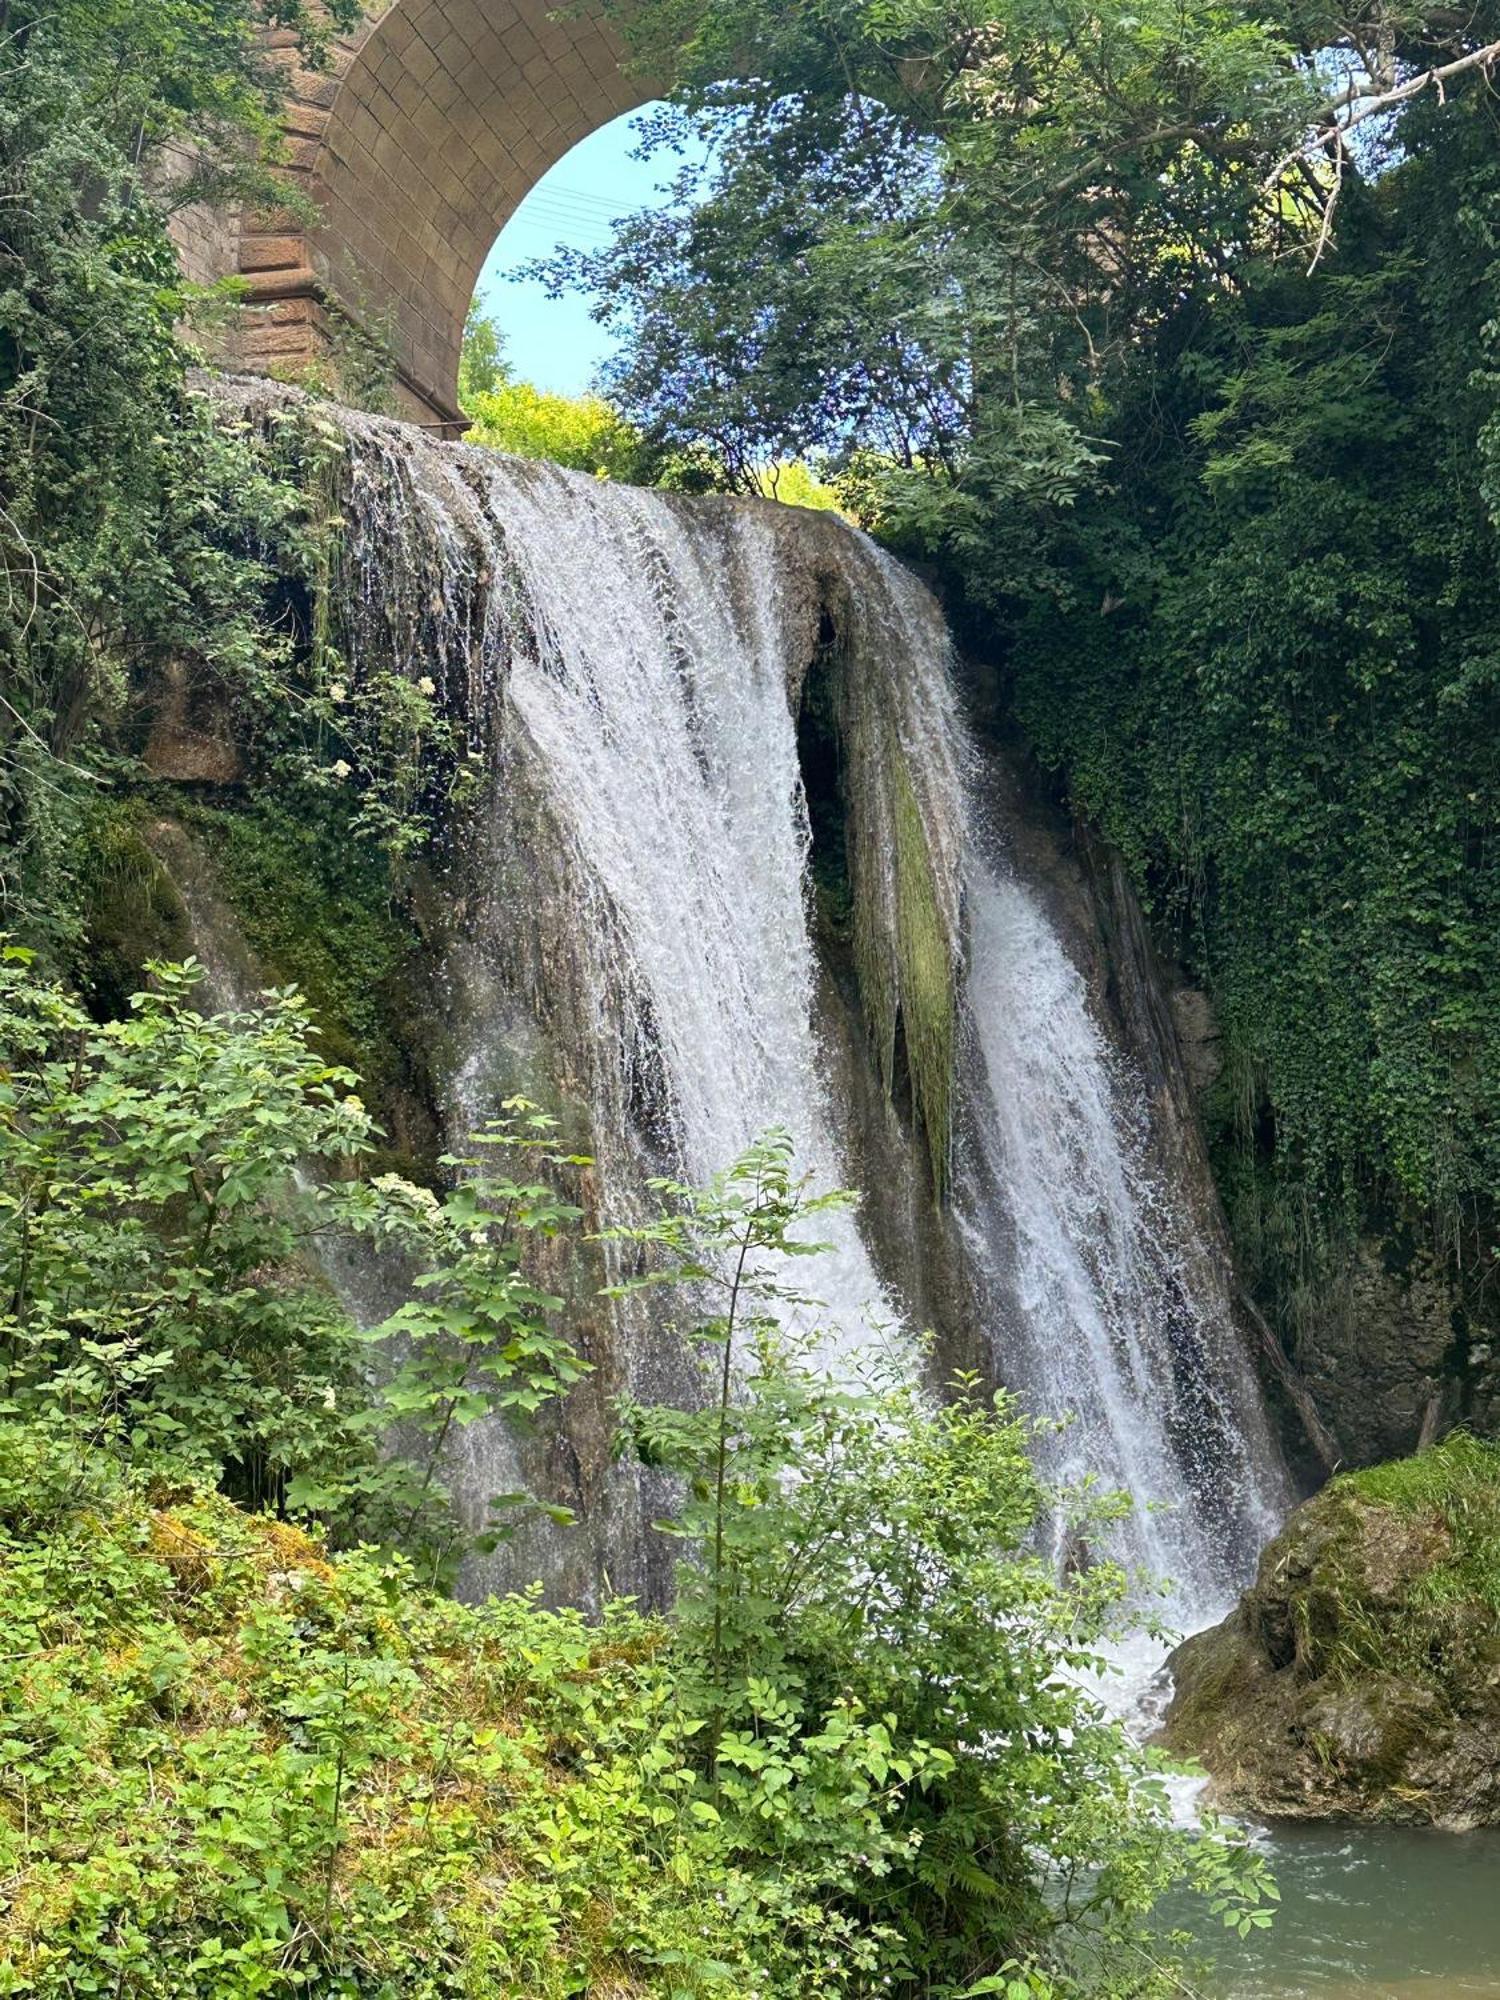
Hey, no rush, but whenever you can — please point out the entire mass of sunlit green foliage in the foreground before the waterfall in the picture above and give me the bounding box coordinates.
[0,1072,1270,2000]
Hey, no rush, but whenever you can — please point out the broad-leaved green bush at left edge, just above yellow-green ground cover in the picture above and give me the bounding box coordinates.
[0,946,382,1506]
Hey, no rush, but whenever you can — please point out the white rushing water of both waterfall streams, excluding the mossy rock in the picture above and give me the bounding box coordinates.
[464,450,1276,1622]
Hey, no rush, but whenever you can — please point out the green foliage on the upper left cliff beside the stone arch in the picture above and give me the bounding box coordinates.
[0,0,340,922]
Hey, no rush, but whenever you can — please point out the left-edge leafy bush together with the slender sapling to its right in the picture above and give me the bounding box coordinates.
[0,946,582,1566]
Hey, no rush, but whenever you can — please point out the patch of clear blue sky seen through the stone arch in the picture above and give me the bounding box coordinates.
[478,112,700,396]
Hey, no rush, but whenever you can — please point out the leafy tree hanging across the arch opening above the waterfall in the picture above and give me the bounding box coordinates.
[532,0,1336,508]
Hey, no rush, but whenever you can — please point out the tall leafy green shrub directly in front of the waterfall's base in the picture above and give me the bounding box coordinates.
[622,1134,1270,2000]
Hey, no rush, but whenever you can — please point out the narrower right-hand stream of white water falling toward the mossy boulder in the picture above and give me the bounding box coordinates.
[964,856,1280,1626]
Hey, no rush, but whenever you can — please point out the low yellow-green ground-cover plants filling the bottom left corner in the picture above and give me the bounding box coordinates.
[0,1424,754,2000]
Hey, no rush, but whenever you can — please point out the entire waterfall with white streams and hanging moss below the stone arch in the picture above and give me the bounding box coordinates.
[226,390,1280,1618]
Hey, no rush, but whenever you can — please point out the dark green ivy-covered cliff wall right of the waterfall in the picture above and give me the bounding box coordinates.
[1010,94,1500,1456]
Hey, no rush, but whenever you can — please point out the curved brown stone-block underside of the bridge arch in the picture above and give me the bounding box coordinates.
[238,0,652,422]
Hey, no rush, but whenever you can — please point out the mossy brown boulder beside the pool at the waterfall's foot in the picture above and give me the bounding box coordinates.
[1164,1436,1500,1828]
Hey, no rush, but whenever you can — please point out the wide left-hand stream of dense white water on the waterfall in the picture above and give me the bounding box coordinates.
[464,462,924,1368]
